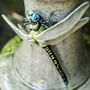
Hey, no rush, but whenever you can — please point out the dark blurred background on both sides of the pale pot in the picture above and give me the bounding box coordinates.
[0,0,90,50]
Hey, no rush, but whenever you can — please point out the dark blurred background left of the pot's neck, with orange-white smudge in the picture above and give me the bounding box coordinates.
[0,0,24,50]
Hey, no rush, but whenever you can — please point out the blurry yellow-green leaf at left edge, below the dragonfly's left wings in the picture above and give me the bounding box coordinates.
[0,36,22,57]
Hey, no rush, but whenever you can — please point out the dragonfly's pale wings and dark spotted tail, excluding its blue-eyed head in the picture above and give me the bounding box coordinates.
[2,2,89,85]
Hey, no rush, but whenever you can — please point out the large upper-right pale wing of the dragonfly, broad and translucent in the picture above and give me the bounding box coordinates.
[35,2,89,43]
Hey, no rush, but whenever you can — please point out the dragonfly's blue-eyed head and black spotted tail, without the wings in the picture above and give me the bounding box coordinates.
[25,11,68,85]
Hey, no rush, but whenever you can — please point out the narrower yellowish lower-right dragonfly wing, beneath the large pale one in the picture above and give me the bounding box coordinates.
[47,17,89,45]
